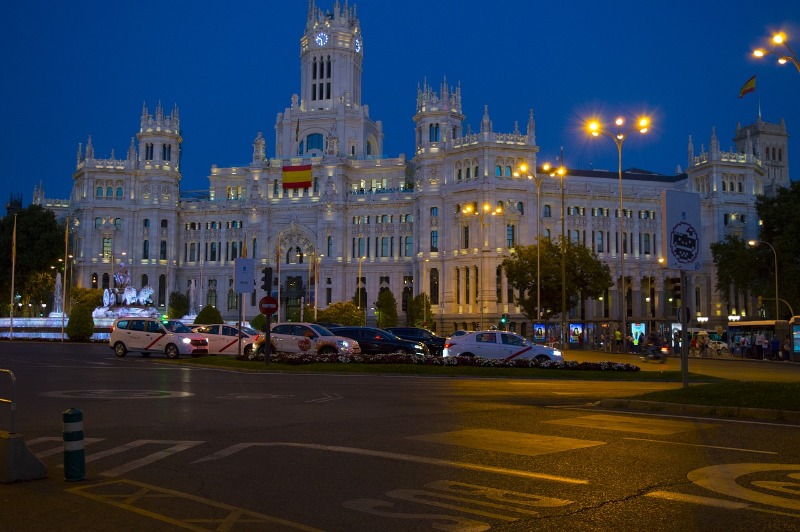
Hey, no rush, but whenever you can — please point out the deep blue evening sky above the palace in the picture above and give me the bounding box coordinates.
[0,0,800,207]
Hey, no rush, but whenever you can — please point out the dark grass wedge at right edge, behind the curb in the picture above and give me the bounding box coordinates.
[630,381,800,411]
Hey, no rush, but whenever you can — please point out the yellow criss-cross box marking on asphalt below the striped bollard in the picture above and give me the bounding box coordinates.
[66,480,322,532]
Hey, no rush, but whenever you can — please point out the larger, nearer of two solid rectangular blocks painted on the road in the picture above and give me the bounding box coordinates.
[407,429,606,456]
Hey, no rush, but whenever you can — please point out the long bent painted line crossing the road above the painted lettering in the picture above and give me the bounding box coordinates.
[192,442,589,484]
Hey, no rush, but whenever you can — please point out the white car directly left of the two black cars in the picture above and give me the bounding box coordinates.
[255,323,361,355]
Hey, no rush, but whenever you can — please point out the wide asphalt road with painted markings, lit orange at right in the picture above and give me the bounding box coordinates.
[0,342,800,531]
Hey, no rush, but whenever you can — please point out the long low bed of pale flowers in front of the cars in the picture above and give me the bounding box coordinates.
[238,353,639,371]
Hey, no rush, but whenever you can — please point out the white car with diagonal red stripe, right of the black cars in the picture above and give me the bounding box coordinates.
[442,331,564,362]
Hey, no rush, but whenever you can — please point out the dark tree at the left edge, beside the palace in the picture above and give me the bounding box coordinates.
[0,205,64,312]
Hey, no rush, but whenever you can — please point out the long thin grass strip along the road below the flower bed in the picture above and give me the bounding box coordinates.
[167,356,719,382]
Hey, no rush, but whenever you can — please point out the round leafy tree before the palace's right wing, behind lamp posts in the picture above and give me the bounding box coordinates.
[501,239,613,320]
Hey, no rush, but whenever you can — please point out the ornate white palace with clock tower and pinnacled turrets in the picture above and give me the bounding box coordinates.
[34,0,789,335]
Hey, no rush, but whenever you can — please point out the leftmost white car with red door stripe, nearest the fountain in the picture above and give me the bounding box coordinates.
[108,316,208,358]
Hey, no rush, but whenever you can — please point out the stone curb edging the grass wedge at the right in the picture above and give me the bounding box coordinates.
[598,399,800,424]
